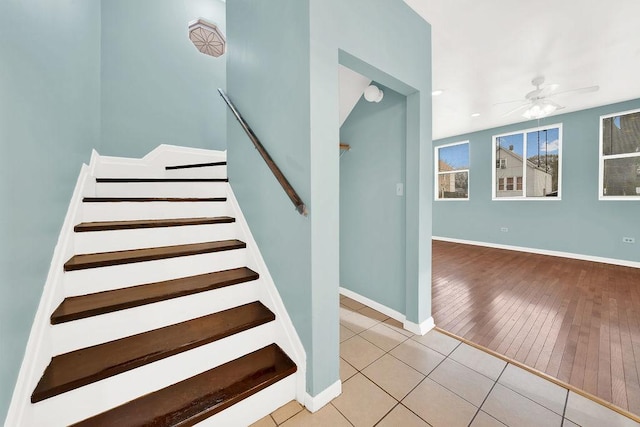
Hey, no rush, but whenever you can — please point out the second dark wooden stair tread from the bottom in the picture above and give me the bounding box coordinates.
[31,301,275,403]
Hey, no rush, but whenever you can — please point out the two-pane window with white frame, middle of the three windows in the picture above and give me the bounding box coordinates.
[493,124,562,200]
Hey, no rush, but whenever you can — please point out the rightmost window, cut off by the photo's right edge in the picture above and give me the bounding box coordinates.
[600,110,640,200]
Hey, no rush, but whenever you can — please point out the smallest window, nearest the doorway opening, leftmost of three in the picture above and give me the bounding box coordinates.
[434,141,469,200]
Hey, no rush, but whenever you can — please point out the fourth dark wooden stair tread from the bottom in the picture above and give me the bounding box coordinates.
[64,239,246,271]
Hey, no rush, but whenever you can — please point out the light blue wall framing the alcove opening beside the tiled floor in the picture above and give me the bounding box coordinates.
[311,0,433,330]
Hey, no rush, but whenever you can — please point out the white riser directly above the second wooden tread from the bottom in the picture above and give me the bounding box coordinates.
[51,281,257,355]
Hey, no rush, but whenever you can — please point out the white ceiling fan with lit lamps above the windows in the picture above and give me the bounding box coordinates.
[496,76,600,119]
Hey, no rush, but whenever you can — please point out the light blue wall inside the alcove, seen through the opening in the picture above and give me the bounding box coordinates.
[340,83,407,313]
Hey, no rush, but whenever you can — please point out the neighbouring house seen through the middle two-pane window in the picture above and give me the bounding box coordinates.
[496,146,555,197]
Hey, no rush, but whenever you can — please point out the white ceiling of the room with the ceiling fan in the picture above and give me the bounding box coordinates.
[404,0,640,139]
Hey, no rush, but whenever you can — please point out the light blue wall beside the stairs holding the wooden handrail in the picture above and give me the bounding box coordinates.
[227,0,313,392]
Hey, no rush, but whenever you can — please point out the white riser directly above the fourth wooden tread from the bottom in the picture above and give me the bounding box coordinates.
[74,223,238,254]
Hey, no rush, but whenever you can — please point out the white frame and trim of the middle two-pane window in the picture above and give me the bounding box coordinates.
[491,123,564,202]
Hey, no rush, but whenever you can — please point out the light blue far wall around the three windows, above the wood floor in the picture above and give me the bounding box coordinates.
[433,100,640,262]
